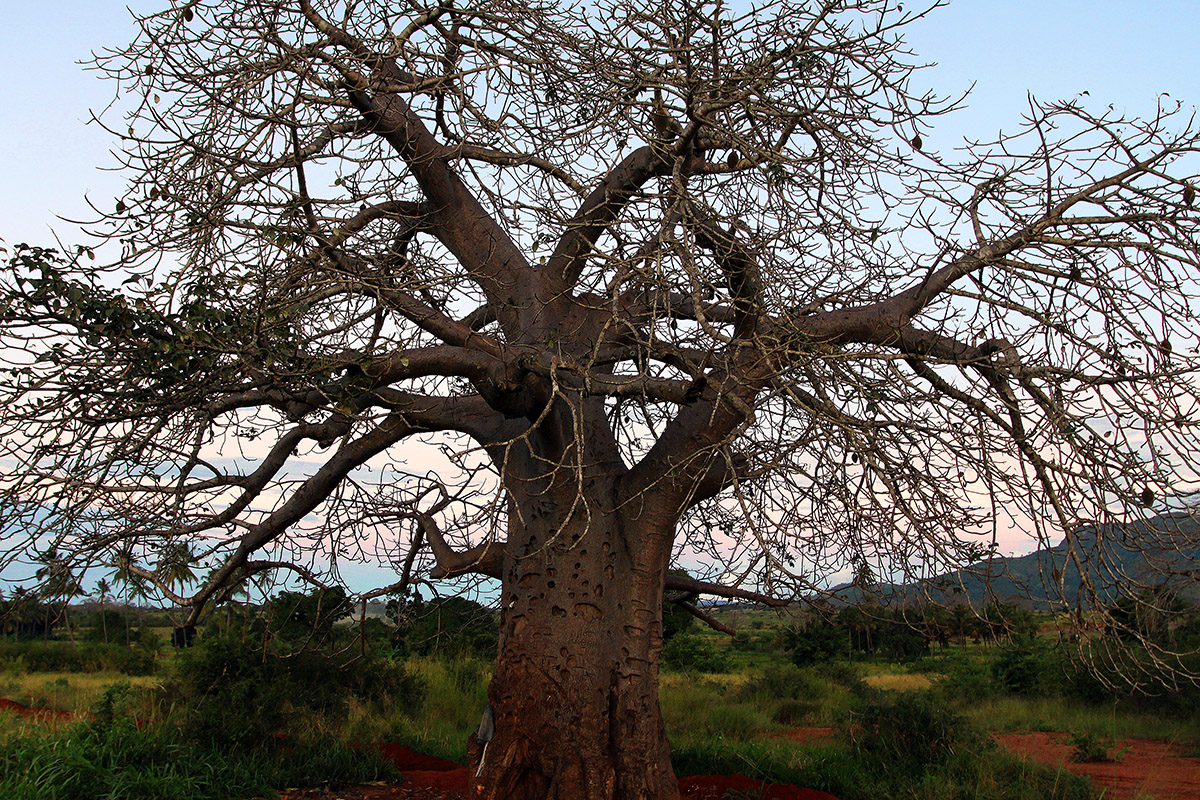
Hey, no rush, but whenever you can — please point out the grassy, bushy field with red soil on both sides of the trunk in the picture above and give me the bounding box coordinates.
[0,599,1200,800]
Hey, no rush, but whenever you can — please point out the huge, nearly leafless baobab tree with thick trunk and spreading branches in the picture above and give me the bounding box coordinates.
[0,0,1200,800]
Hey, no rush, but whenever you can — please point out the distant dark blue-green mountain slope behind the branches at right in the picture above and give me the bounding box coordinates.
[834,509,1200,608]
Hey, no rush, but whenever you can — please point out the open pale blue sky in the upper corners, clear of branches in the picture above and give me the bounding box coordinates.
[0,0,1200,245]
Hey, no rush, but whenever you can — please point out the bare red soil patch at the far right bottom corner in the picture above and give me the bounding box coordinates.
[995,733,1200,800]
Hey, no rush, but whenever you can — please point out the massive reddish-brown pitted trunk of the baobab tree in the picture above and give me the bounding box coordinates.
[470,402,678,800]
